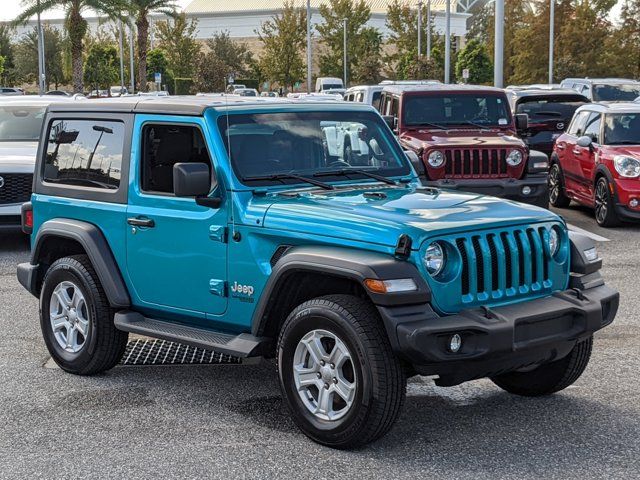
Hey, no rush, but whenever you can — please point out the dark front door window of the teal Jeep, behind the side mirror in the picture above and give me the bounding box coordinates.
[140,124,212,195]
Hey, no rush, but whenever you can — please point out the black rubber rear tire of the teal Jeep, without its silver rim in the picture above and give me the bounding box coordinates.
[40,255,128,375]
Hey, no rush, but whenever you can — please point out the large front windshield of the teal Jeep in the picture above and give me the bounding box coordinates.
[218,111,411,186]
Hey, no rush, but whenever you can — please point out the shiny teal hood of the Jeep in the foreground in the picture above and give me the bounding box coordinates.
[255,185,559,249]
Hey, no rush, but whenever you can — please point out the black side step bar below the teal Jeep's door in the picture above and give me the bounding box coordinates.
[114,310,271,358]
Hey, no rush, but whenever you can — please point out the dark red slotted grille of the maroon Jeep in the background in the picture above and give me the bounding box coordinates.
[444,148,509,178]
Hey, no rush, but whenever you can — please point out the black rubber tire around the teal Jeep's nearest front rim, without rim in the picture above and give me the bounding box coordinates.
[278,295,406,449]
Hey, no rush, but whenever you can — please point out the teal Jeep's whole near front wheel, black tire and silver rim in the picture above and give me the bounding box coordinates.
[278,295,406,448]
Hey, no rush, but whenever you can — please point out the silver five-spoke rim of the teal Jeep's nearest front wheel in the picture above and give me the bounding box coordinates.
[293,330,356,421]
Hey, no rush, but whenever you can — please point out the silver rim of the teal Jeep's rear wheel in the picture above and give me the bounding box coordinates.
[49,281,89,353]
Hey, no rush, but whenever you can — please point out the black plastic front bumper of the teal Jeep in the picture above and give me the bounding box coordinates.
[379,281,619,385]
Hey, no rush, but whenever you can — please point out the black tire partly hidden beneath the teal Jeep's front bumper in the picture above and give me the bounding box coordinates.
[491,337,593,397]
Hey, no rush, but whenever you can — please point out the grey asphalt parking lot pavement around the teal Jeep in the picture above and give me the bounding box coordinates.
[0,212,640,479]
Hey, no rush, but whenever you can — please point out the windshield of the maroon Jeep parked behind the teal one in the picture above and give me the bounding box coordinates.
[403,93,511,127]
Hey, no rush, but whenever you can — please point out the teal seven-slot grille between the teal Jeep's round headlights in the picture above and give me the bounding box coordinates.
[455,227,552,303]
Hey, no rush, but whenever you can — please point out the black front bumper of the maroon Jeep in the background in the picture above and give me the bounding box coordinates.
[422,173,549,205]
